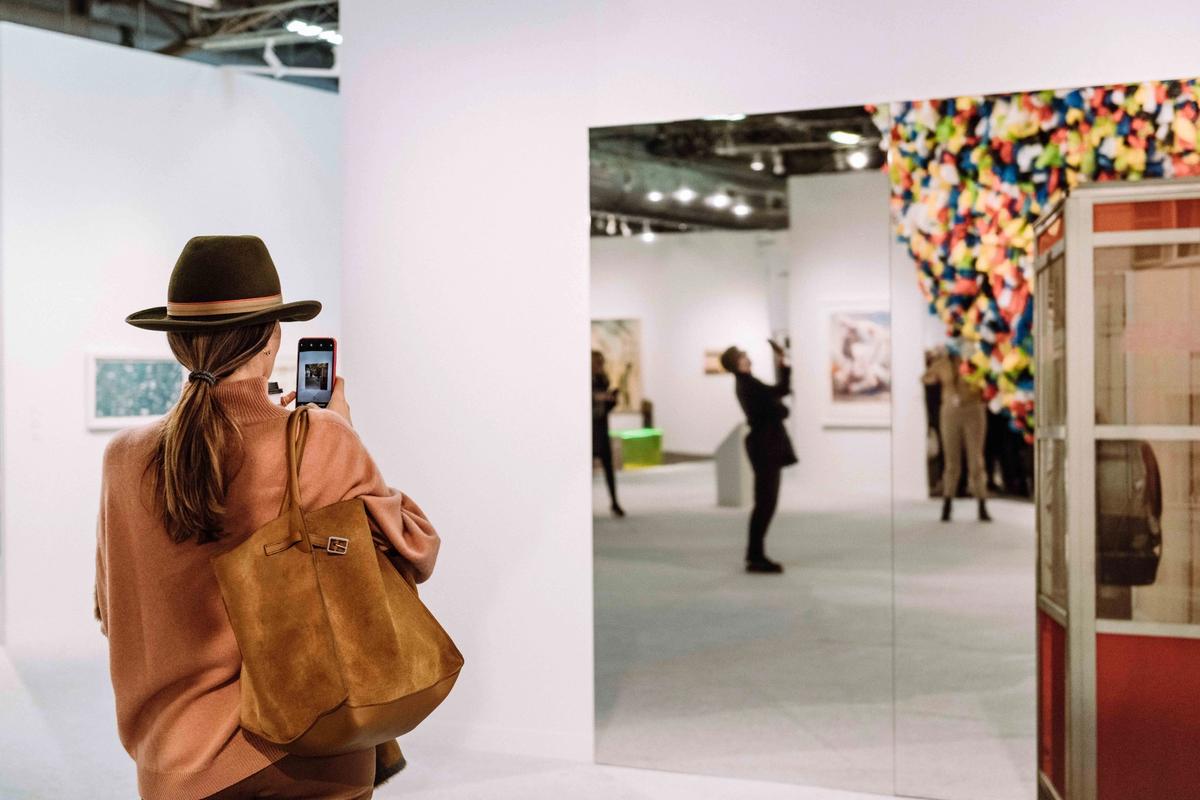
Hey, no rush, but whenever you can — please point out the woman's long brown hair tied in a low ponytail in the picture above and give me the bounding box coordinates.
[149,323,275,543]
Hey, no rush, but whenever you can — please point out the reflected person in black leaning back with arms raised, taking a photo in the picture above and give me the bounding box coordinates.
[721,342,798,572]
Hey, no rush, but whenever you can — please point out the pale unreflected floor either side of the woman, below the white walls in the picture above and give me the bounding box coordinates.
[0,648,878,800]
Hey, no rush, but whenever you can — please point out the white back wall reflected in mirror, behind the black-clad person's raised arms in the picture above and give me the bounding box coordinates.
[590,231,788,456]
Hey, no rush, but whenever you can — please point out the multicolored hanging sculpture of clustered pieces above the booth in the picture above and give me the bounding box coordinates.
[868,79,1200,438]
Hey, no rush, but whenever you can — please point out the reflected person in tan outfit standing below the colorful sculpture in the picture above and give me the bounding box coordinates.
[920,350,991,522]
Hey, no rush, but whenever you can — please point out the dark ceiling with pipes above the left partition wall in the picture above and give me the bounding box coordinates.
[0,0,341,91]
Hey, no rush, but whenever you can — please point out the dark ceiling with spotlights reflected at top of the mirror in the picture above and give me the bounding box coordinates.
[590,107,884,236]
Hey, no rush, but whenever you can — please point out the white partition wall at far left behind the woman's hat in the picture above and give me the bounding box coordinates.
[0,24,341,652]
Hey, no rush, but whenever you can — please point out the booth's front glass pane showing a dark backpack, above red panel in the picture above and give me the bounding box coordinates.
[1096,440,1200,624]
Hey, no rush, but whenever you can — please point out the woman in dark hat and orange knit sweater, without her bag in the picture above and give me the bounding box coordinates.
[96,236,439,800]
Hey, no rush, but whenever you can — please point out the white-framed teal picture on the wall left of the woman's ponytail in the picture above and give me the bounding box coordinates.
[86,353,186,431]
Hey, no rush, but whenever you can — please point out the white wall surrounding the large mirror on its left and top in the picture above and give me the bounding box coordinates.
[342,0,1200,759]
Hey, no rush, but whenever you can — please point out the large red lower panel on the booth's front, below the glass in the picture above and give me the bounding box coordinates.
[1096,633,1200,800]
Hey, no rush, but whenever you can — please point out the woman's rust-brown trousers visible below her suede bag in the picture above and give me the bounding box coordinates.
[205,747,374,800]
